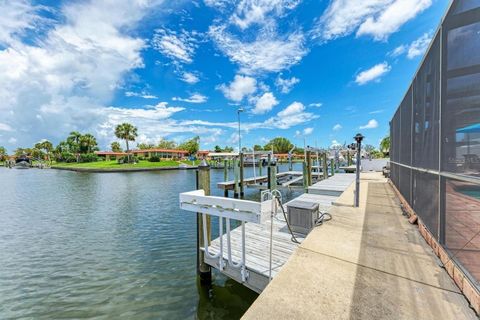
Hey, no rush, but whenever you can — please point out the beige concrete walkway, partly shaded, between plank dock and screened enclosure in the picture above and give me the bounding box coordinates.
[243,173,478,319]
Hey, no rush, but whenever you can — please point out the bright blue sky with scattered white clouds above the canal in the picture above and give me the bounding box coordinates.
[0,0,449,151]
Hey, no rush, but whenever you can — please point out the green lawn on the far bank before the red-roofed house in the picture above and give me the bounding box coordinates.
[53,160,187,169]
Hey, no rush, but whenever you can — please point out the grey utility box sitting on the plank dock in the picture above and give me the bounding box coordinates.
[287,200,319,235]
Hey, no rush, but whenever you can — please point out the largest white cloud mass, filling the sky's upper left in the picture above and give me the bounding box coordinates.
[0,1,152,145]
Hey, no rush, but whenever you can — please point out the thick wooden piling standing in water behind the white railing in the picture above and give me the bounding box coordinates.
[197,160,212,284]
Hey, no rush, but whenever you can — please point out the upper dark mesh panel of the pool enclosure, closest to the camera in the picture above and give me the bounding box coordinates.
[442,14,480,177]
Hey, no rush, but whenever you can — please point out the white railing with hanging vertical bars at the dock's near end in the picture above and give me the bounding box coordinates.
[180,190,272,282]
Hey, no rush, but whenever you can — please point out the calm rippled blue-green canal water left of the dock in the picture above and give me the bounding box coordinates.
[0,164,304,319]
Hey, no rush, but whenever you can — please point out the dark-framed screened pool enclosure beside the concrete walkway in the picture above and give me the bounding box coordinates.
[390,0,480,288]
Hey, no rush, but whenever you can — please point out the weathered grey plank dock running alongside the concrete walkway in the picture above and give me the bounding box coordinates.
[205,172,355,292]
